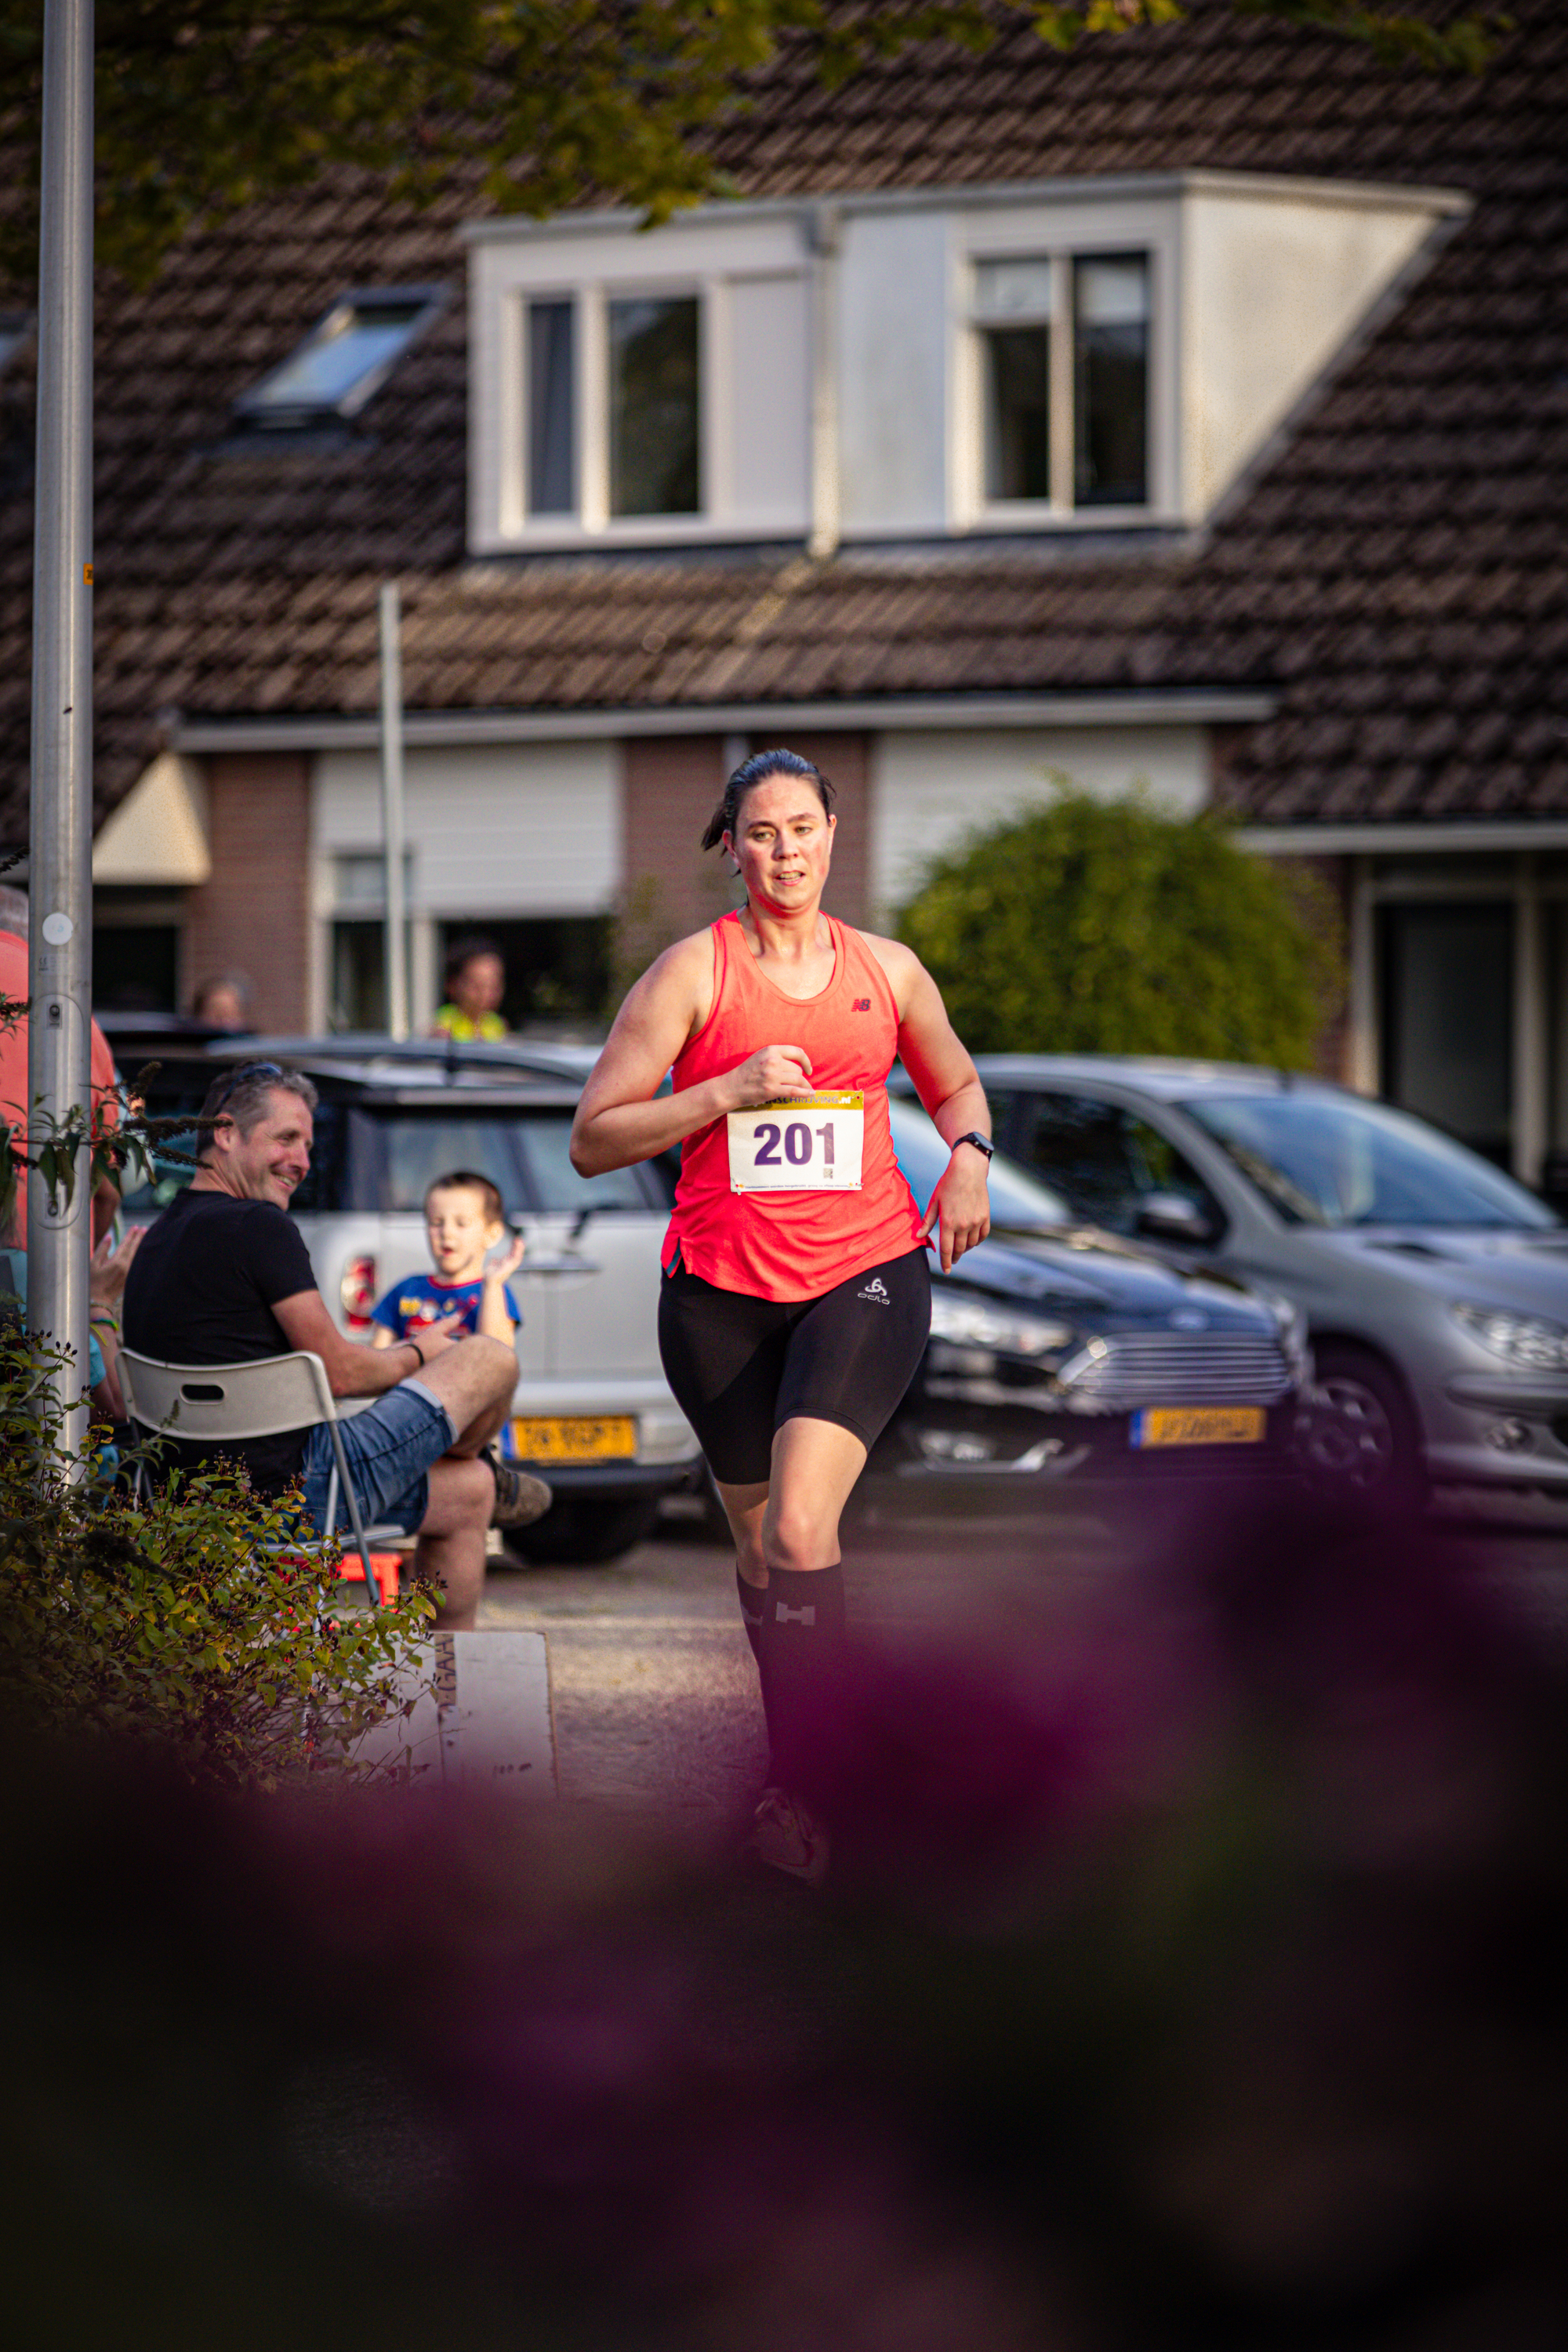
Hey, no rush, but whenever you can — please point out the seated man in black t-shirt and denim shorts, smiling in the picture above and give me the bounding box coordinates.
[125,1061,550,1630]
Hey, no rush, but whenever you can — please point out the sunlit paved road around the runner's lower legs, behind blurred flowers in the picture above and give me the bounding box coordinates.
[480,1517,1568,1842]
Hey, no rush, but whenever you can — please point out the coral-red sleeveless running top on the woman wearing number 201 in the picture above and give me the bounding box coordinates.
[663,915,921,1301]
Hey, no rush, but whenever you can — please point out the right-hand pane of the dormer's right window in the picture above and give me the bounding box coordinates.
[1072,254,1149,506]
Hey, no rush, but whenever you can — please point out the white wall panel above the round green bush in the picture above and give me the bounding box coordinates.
[869,727,1210,917]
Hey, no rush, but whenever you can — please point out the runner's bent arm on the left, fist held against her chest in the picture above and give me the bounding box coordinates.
[572,931,811,1176]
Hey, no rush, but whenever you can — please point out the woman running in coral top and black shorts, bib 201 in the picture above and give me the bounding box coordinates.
[572,750,989,1879]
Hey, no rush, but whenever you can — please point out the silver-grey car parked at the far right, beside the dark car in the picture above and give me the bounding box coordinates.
[964,1054,1568,1505]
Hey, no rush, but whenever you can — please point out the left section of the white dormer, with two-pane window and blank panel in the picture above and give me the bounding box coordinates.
[468,207,815,550]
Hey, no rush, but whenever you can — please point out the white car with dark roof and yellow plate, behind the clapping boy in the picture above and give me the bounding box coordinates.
[111,1021,701,1562]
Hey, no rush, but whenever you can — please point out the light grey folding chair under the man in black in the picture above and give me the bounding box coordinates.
[118,1348,402,1609]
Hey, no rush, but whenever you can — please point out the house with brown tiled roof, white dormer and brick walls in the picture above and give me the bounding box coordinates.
[0,0,1568,1181]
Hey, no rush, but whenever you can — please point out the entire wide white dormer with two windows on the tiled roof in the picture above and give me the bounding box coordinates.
[468,172,1467,555]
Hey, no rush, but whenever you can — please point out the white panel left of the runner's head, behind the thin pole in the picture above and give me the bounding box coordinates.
[313,741,621,922]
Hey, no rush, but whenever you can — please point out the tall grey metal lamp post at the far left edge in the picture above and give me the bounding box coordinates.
[28,0,94,1458]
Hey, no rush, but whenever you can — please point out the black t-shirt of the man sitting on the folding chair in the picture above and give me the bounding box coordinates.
[125,1192,315,1494]
